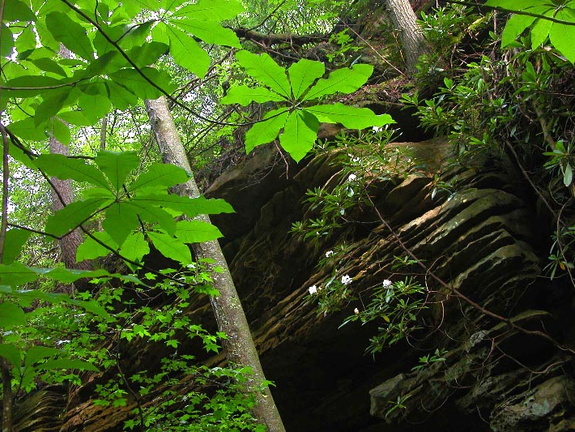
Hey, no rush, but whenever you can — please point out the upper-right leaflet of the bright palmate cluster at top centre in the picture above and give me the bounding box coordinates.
[304,64,373,100]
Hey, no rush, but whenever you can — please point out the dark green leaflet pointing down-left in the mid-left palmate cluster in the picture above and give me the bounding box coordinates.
[46,198,111,237]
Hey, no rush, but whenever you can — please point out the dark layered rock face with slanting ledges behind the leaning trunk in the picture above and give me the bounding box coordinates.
[16,140,575,432]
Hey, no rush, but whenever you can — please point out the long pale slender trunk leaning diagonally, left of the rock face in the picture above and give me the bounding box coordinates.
[146,97,285,432]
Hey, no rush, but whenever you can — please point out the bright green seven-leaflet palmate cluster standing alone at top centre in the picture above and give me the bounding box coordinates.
[222,51,393,161]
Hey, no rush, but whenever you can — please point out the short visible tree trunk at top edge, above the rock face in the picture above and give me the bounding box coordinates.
[385,0,427,75]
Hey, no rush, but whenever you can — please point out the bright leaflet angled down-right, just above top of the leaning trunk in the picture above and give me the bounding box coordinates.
[166,26,211,78]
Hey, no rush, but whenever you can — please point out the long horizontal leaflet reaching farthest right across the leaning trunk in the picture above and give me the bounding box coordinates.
[132,194,234,218]
